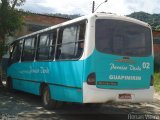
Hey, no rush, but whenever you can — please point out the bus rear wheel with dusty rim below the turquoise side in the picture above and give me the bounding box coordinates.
[42,86,57,110]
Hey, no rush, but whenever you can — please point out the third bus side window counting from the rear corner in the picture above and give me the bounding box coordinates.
[22,37,36,61]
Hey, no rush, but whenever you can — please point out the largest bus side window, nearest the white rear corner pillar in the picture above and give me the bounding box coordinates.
[56,20,85,60]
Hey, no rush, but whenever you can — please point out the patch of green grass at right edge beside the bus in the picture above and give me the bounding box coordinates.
[154,71,160,93]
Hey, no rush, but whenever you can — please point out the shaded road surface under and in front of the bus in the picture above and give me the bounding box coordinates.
[0,88,160,120]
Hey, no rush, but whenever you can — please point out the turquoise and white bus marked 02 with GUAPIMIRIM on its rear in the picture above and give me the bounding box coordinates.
[7,13,154,109]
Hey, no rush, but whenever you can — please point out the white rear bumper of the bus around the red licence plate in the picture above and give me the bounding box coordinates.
[83,83,154,103]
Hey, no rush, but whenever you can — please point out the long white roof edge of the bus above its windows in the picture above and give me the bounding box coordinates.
[11,12,151,44]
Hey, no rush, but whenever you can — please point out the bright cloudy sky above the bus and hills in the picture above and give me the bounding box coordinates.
[20,0,160,15]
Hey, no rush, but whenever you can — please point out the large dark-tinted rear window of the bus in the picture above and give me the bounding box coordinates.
[95,19,152,57]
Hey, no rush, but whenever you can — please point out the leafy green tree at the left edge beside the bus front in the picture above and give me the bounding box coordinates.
[0,0,25,85]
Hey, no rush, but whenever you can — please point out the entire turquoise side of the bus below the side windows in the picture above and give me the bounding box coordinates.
[8,61,83,102]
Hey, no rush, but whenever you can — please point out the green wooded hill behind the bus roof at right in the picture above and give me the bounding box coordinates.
[128,12,160,30]
